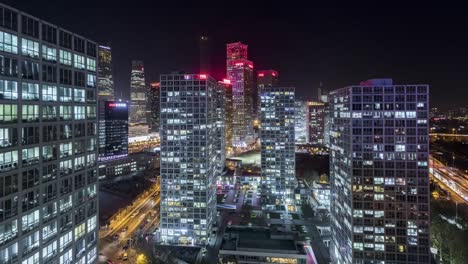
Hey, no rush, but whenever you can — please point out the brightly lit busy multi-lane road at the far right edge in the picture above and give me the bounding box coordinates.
[429,157,468,203]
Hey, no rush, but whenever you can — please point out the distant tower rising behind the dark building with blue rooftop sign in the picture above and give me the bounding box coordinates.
[98,45,114,101]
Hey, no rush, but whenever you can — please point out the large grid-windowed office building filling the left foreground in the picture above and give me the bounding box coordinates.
[0,4,99,264]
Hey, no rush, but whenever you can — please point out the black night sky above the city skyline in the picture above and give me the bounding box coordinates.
[2,0,468,109]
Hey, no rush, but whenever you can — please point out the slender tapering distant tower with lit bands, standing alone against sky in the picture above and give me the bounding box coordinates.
[128,61,148,136]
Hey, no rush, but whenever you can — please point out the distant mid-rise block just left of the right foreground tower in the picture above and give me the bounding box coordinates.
[307,101,325,145]
